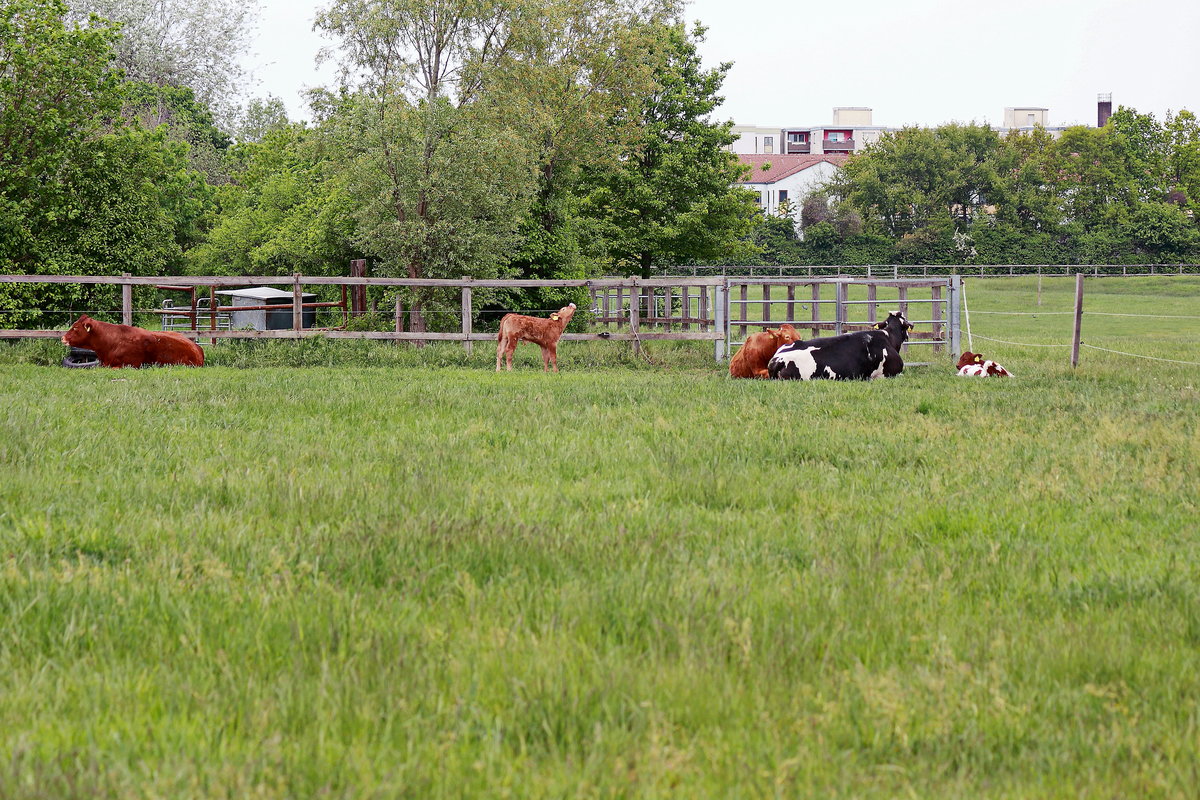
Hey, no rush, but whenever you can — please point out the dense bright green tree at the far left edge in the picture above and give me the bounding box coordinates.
[0,0,209,326]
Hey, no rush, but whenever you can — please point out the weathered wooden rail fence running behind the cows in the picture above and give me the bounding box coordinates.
[0,273,961,360]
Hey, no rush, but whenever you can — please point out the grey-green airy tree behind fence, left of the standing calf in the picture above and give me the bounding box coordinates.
[318,0,552,331]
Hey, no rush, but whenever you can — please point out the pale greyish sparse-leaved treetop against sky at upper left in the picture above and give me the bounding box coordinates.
[70,0,258,125]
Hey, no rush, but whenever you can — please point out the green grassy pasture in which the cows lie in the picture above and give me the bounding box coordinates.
[0,278,1200,799]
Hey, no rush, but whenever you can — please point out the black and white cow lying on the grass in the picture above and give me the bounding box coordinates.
[767,311,912,380]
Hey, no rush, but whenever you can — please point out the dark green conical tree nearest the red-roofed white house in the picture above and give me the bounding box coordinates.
[583,23,756,276]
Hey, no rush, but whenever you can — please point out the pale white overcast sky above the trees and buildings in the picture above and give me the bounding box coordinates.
[247,0,1200,127]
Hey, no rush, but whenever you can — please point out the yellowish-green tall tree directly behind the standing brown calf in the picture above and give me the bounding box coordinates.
[490,0,674,308]
